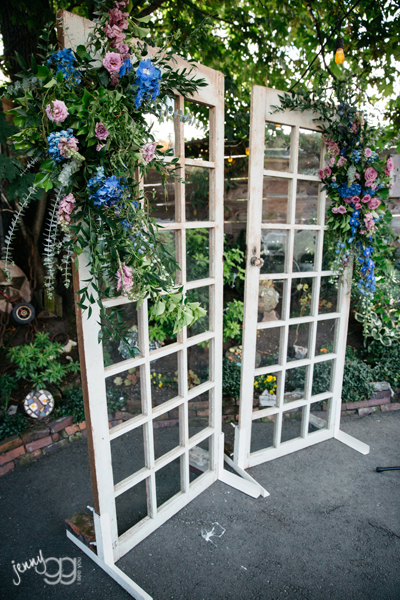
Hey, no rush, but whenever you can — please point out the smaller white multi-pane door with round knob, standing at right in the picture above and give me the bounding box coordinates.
[234,86,368,469]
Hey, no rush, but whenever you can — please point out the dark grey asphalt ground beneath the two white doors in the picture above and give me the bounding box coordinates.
[0,413,400,600]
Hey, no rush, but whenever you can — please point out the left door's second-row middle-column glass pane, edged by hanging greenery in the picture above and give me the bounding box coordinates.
[144,168,175,223]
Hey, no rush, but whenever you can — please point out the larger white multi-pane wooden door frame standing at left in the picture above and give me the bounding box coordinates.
[60,11,267,598]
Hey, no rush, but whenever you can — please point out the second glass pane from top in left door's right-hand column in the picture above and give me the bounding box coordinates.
[185,167,210,221]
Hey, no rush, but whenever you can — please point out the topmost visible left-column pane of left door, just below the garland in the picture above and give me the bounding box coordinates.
[102,302,141,367]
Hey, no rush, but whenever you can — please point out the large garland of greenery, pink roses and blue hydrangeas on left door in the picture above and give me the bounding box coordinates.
[4,0,206,342]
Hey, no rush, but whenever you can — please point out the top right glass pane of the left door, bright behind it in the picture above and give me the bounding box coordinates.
[183,100,210,160]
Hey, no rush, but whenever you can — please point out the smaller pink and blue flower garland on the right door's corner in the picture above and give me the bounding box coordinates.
[275,82,394,328]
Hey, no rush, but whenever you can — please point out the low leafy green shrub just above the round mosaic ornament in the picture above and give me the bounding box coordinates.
[7,333,79,389]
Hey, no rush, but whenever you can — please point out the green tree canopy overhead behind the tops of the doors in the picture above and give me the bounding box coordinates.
[0,0,400,140]
